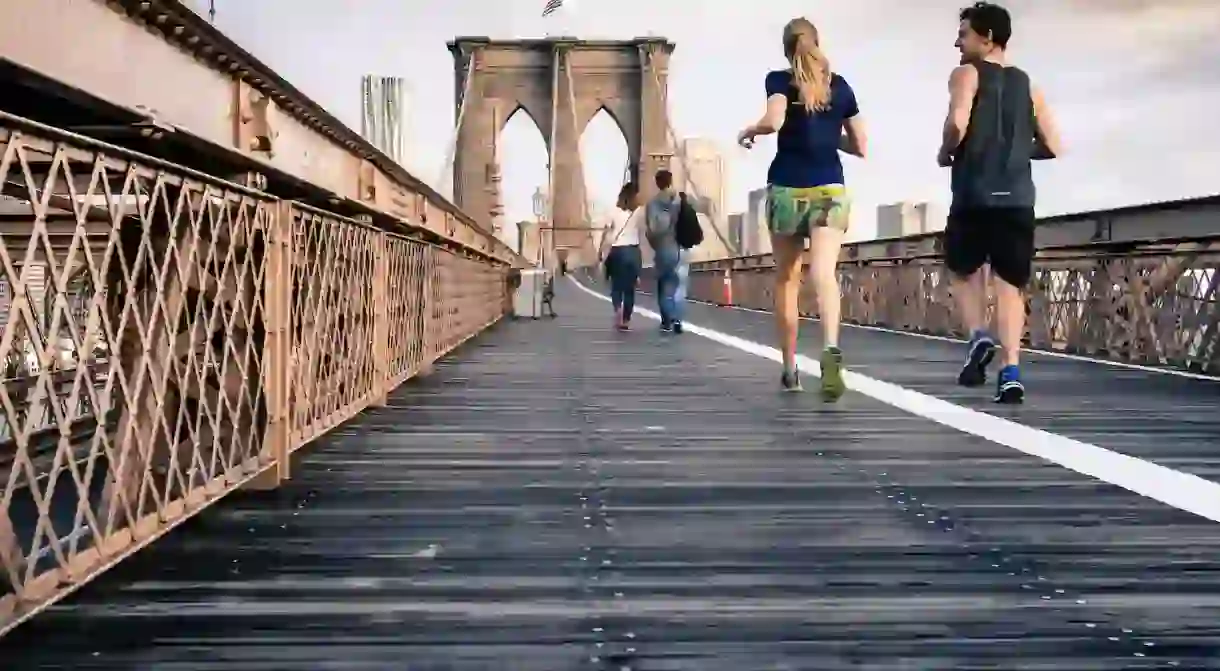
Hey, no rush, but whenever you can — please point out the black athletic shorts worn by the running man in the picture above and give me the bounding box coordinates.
[944,207,1035,288]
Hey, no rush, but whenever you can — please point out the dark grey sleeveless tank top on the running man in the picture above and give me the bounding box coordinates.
[952,61,1036,210]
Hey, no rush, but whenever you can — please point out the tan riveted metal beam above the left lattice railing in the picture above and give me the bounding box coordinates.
[0,0,522,265]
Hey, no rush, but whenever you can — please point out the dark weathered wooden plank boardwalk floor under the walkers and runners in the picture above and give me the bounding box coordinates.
[0,282,1220,671]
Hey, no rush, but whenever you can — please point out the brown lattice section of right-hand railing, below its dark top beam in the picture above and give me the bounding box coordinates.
[689,237,1220,373]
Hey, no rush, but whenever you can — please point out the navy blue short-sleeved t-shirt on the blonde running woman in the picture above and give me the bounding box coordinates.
[766,70,860,188]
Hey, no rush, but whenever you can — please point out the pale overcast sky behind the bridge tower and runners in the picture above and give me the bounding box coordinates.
[188,0,1220,238]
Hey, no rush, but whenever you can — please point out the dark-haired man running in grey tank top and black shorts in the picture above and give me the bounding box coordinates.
[937,2,1060,403]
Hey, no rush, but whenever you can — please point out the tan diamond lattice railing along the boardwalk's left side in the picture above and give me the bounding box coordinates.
[0,115,509,632]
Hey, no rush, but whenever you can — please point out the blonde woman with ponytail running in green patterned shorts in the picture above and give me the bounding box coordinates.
[737,18,866,401]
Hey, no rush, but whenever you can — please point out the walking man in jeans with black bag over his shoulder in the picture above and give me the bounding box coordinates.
[644,170,703,333]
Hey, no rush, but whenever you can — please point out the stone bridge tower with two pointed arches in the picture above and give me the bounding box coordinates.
[449,37,675,263]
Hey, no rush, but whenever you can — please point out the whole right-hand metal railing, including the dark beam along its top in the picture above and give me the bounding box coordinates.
[678,198,1220,373]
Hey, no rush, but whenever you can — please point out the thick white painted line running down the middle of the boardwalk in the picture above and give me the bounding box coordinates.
[572,278,1220,522]
